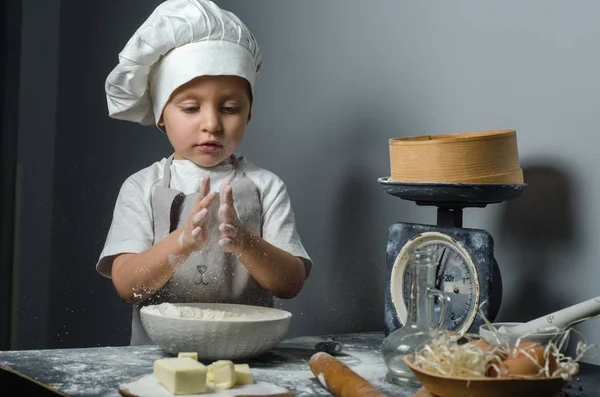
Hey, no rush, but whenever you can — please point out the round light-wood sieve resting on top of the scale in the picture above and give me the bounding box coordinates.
[389,130,523,184]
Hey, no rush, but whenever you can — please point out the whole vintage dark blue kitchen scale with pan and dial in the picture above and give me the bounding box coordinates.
[378,178,527,336]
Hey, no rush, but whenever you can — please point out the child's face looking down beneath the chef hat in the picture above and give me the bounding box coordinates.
[158,76,251,167]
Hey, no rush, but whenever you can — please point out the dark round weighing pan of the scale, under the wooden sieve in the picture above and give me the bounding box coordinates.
[377,177,527,208]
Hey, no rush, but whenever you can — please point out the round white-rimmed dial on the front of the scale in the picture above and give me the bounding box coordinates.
[390,232,480,336]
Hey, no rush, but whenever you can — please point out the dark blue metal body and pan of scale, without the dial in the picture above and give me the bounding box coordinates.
[377,177,527,335]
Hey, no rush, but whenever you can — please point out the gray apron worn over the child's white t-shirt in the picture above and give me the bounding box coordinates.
[130,155,273,346]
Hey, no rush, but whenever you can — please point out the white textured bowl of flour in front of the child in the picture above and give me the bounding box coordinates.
[140,303,292,361]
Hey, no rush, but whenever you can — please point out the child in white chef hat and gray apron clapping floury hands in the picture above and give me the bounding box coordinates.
[96,0,312,345]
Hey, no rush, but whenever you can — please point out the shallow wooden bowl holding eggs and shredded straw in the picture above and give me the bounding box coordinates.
[404,356,567,397]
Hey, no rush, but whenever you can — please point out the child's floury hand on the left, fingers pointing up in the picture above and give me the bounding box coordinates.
[179,176,216,251]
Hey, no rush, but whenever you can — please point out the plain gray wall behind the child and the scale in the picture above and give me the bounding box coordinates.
[12,0,600,363]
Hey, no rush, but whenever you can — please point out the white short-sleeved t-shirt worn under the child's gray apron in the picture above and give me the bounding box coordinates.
[96,157,312,278]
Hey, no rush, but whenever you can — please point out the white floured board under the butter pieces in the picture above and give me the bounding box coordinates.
[119,374,288,397]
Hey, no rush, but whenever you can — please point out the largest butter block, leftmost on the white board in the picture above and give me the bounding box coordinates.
[153,357,206,394]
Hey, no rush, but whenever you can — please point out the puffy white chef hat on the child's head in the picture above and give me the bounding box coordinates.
[105,0,262,125]
